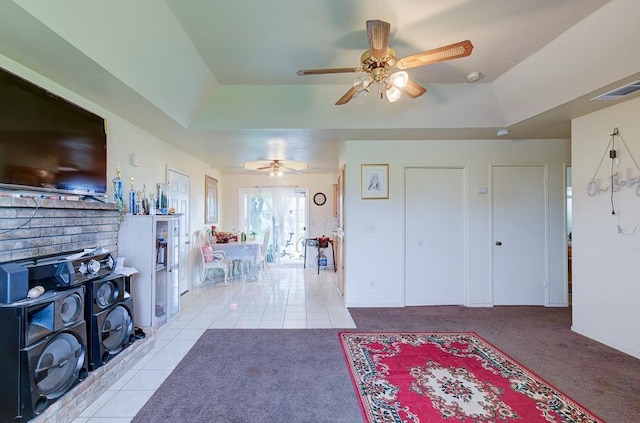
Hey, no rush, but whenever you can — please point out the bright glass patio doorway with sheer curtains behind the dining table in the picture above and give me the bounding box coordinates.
[238,187,309,265]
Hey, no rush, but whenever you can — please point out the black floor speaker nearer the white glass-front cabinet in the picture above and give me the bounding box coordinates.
[85,275,135,370]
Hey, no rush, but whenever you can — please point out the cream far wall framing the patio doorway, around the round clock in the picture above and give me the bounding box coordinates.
[220,173,337,237]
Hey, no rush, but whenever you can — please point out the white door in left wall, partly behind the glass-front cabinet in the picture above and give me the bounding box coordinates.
[167,169,191,294]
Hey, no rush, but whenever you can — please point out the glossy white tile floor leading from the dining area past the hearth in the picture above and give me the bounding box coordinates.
[72,266,355,423]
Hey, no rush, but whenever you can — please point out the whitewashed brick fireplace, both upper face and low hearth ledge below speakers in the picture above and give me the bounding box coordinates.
[0,196,155,423]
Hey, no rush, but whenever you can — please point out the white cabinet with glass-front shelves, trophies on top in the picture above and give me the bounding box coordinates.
[118,215,180,328]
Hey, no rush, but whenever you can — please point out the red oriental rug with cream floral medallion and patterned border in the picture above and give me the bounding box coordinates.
[340,332,601,423]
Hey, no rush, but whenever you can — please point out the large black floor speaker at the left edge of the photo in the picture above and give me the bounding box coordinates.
[0,286,88,422]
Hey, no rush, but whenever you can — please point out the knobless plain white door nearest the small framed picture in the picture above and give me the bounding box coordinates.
[405,168,465,306]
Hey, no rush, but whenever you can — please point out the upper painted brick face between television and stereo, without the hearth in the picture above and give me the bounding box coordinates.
[0,193,120,263]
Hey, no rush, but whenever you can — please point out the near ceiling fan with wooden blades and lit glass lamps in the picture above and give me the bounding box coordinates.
[298,20,473,106]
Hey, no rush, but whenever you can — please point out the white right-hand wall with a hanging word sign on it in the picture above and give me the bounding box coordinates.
[571,98,640,358]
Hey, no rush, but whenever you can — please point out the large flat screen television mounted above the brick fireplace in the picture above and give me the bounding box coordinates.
[0,68,107,197]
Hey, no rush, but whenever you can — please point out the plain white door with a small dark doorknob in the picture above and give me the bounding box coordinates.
[492,165,547,305]
